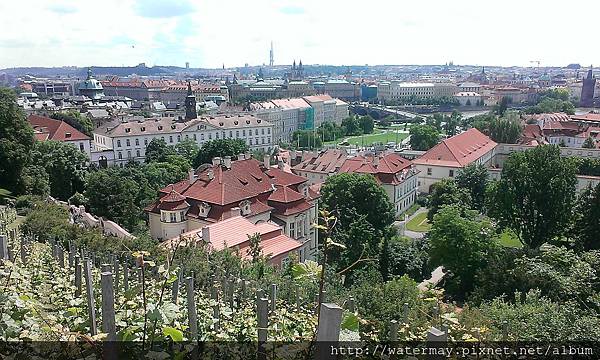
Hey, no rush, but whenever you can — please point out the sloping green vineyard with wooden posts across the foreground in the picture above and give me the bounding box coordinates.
[0,201,576,359]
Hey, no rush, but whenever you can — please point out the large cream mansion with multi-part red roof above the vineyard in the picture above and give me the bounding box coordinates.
[145,154,318,260]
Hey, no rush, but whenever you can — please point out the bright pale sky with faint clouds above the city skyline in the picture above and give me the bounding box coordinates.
[0,0,600,68]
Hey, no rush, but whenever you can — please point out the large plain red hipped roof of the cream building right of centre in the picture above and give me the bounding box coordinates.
[413,128,497,167]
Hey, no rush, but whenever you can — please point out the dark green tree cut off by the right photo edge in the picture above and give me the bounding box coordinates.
[574,184,600,250]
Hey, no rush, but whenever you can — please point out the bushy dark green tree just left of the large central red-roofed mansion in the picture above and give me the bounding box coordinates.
[85,167,142,229]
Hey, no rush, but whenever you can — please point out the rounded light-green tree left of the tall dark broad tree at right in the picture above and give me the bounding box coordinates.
[429,205,496,295]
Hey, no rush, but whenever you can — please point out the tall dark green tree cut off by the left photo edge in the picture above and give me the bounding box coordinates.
[0,88,34,194]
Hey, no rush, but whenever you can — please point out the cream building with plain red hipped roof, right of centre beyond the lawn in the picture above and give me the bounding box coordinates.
[413,128,497,193]
